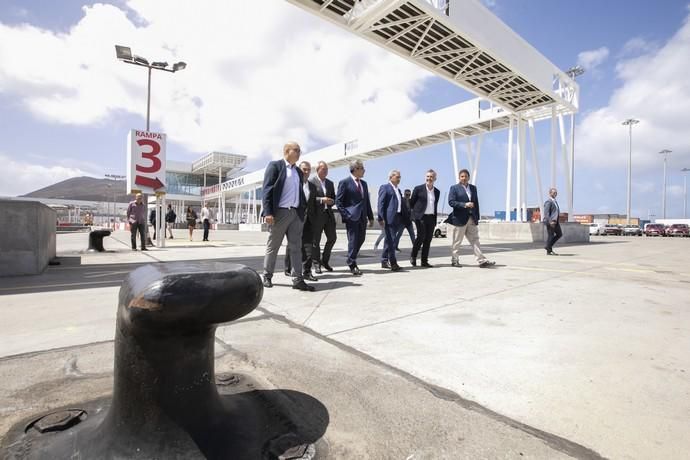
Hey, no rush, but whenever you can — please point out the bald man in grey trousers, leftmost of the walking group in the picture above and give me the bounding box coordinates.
[262,142,314,291]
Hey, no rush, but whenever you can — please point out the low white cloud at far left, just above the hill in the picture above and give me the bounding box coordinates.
[0,153,93,196]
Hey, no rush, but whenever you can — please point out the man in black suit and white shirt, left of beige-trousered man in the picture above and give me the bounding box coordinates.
[410,169,441,267]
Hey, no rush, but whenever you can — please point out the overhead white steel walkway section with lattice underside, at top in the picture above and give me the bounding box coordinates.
[287,0,577,112]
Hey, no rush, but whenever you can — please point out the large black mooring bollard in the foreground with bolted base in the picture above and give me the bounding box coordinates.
[3,262,328,459]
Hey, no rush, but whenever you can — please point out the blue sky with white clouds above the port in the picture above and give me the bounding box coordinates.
[0,0,690,218]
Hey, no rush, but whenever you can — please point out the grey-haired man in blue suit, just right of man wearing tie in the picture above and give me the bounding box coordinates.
[377,169,409,272]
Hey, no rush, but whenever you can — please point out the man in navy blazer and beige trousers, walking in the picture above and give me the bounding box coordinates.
[447,169,496,268]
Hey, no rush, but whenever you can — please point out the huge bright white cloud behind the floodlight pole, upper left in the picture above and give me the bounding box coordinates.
[0,0,430,160]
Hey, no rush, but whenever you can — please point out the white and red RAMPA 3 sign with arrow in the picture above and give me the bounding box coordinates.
[127,129,165,194]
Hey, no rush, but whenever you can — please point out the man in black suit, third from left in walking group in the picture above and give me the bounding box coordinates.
[309,161,337,274]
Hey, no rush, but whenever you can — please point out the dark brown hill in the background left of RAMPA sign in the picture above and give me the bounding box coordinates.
[22,177,132,203]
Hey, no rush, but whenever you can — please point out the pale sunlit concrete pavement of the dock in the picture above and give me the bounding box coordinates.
[0,230,690,459]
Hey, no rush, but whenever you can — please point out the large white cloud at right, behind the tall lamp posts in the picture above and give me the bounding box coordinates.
[575,10,690,174]
